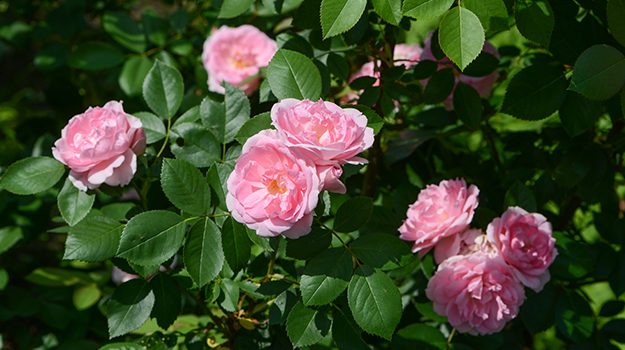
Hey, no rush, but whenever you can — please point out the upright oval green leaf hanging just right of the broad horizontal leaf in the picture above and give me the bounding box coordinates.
[184,218,224,287]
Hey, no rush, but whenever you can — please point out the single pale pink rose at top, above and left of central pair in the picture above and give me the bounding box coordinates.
[202,24,278,96]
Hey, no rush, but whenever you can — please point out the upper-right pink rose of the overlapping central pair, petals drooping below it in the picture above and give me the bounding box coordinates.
[271,98,374,193]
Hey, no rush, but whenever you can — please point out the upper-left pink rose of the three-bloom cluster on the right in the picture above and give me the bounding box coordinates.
[399,179,480,258]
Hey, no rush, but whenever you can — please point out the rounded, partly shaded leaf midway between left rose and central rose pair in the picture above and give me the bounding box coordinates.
[171,123,221,167]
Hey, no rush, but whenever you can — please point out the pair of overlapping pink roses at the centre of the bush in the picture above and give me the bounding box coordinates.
[226,99,374,238]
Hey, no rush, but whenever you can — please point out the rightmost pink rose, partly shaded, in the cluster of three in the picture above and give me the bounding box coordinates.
[486,207,558,292]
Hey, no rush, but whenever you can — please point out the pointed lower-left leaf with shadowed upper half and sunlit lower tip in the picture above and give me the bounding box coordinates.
[107,279,154,339]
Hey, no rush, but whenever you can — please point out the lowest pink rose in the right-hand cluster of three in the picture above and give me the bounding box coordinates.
[425,251,525,335]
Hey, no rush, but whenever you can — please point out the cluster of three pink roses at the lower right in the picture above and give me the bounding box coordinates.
[399,179,558,335]
